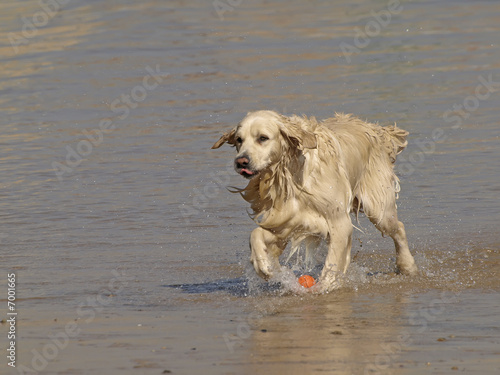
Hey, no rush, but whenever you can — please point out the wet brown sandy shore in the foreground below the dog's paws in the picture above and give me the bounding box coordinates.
[5,249,500,374]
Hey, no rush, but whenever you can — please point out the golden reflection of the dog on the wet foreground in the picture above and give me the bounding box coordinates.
[250,292,408,374]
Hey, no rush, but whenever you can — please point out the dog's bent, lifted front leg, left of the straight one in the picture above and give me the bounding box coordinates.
[250,228,286,280]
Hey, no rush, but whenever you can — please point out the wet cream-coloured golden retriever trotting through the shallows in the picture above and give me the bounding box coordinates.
[212,111,417,293]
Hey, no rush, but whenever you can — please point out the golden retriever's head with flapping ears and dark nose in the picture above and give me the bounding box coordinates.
[212,111,316,179]
